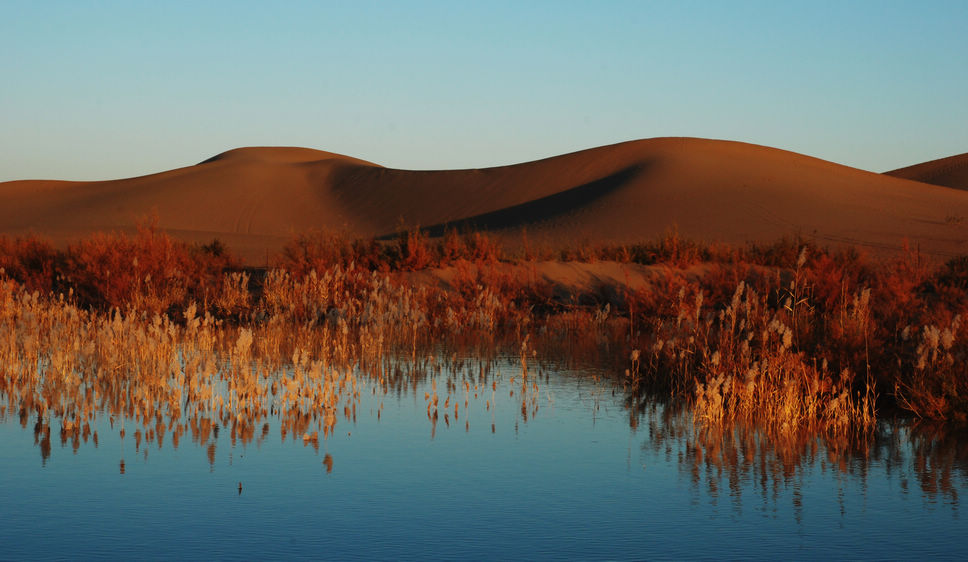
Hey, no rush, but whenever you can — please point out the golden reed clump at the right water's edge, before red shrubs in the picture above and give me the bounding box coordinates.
[629,276,876,434]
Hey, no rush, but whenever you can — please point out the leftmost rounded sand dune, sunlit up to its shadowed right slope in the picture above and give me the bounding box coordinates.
[0,147,373,263]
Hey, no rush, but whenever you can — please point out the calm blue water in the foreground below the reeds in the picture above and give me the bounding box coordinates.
[0,356,968,560]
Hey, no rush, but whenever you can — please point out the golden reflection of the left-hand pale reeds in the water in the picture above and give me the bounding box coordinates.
[0,350,560,474]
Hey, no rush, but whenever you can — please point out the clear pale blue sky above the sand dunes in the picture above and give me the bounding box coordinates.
[0,0,968,180]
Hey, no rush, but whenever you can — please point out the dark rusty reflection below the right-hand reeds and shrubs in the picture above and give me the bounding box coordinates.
[633,401,968,522]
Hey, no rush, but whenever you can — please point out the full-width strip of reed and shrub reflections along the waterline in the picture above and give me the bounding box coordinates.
[7,355,968,520]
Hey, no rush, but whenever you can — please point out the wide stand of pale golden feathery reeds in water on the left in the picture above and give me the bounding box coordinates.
[0,268,552,464]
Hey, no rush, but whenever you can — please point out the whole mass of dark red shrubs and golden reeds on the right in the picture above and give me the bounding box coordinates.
[628,243,968,434]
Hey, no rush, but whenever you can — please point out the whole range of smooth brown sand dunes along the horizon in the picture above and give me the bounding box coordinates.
[0,138,968,263]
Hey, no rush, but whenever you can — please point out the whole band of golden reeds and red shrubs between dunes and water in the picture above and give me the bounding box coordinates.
[0,228,968,464]
